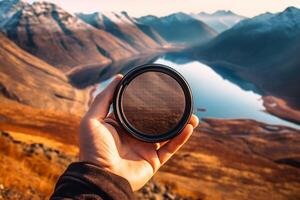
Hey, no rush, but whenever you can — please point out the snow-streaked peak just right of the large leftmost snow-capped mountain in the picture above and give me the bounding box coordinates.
[77,12,168,51]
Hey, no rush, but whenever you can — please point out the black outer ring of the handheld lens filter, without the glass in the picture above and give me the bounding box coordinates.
[113,64,193,143]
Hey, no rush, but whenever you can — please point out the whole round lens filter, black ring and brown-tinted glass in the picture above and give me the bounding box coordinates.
[113,64,193,142]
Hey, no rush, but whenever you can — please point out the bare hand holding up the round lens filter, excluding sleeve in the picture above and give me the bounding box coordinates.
[79,75,198,190]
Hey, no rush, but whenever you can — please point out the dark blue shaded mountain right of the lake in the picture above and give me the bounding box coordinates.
[190,7,300,107]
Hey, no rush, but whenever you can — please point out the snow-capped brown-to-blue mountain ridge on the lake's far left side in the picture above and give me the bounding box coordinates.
[0,0,231,73]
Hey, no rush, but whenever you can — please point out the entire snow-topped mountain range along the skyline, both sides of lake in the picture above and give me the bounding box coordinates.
[0,0,300,110]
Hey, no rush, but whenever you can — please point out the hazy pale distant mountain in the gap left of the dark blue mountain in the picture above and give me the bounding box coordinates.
[192,10,246,33]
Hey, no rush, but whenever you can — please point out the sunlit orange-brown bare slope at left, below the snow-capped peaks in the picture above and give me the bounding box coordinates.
[0,34,89,115]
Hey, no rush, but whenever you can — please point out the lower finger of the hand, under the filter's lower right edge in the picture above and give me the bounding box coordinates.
[157,124,193,165]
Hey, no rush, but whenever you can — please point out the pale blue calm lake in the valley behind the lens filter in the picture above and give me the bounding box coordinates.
[99,57,300,129]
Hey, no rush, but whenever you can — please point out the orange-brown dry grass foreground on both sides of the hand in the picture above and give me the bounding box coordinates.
[0,100,300,199]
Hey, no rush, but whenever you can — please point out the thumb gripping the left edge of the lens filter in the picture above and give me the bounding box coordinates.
[87,74,123,119]
